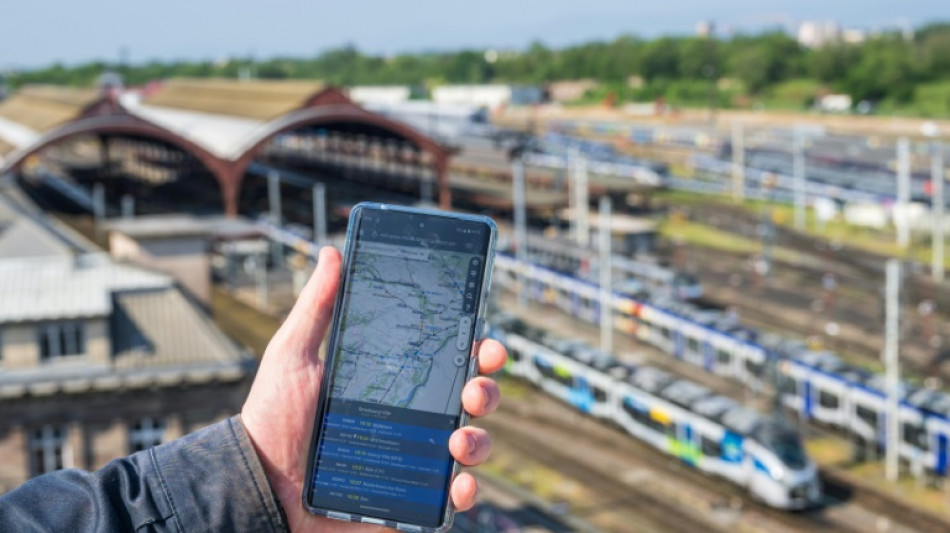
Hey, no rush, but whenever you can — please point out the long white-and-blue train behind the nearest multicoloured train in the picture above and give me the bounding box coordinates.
[494,254,950,476]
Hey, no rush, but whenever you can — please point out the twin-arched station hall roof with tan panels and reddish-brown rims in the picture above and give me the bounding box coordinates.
[0,79,451,214]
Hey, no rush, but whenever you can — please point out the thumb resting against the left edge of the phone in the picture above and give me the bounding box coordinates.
[275,246,341,356]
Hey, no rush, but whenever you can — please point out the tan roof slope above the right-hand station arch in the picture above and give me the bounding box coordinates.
[143,78,325,122]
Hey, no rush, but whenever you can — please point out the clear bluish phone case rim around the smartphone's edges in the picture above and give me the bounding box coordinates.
[301,202,498,533]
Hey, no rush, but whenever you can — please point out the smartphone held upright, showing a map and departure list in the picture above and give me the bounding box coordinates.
[303,203,497,531]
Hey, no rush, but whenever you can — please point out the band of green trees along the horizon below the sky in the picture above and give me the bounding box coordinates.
[7,22,950,115]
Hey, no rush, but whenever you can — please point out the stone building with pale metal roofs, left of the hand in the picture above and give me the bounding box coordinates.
[0,190,256,493]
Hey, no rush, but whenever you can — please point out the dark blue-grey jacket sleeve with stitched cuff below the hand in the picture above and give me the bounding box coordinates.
[0,416,288,533]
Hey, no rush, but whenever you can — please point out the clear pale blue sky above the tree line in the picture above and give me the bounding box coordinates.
[0,0,950,69]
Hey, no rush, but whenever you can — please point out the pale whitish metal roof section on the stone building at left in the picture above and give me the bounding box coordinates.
[0,254,172,323]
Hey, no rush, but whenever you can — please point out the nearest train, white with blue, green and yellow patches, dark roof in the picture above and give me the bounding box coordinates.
[488,313,821,510]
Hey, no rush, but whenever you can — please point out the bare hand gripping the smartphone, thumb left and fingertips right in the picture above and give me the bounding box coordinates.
[241,247,507,532]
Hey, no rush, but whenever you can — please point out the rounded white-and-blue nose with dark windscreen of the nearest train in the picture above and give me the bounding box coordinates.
[749,419,821,510]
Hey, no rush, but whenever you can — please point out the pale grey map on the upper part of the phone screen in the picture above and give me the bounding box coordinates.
[332,241,482,415]
